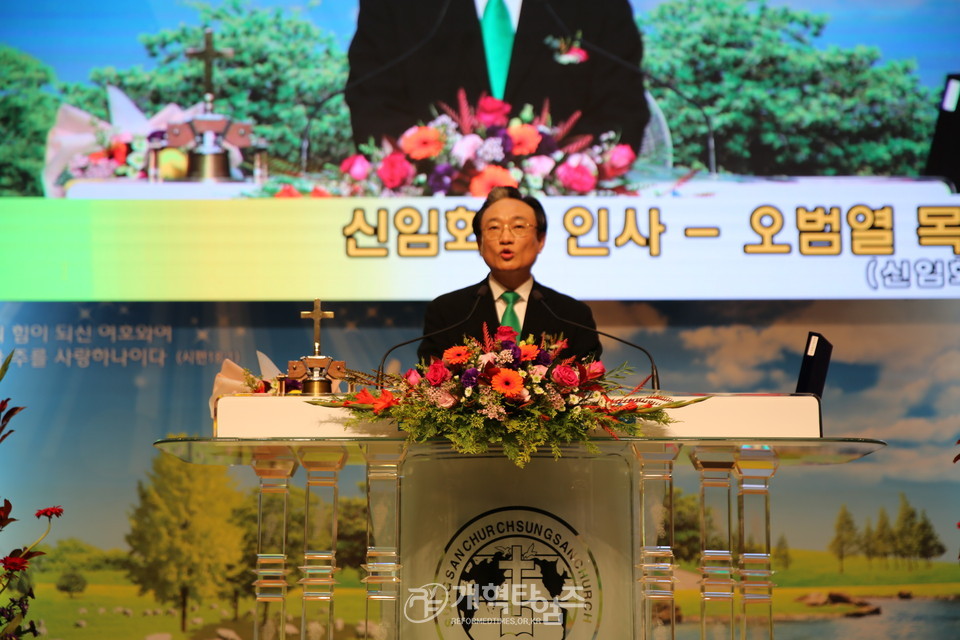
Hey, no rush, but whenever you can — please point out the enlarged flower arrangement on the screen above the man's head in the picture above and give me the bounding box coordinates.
[255,87,639,198]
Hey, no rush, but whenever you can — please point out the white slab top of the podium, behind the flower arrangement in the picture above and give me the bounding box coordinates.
[213,393,823,438]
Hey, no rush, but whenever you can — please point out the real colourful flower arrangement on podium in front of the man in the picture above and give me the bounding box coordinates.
[308,326,706,467]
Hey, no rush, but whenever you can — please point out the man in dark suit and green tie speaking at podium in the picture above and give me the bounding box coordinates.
[417,187,601,363]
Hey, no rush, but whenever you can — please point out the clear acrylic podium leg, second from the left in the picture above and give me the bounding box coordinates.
[297,446,347,639]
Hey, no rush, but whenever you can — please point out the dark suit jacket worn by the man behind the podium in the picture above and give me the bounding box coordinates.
[417,280,601,363]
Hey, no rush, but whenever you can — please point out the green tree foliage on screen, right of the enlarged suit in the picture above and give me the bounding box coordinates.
[640,0,936,175]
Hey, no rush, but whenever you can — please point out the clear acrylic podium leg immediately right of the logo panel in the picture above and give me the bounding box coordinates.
[633,442,680,640]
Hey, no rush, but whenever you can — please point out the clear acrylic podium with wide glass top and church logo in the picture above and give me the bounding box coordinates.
[156,431,885,640]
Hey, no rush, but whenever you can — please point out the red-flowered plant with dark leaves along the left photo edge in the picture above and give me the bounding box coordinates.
[0,352,63,640]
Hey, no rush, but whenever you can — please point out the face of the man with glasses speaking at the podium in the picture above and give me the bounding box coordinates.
[480,198,546,286]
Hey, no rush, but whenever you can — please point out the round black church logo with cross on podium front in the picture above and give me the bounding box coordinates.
[404,507,601,640]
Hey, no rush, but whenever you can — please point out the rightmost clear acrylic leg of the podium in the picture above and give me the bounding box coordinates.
[736,445,778,640]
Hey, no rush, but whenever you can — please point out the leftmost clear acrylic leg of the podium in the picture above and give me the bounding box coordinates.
[251,447,297,640]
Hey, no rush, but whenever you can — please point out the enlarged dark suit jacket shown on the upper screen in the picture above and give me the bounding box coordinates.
[346,0,650,149]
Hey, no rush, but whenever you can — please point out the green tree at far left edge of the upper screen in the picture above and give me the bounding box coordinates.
[0,44,57,197]
